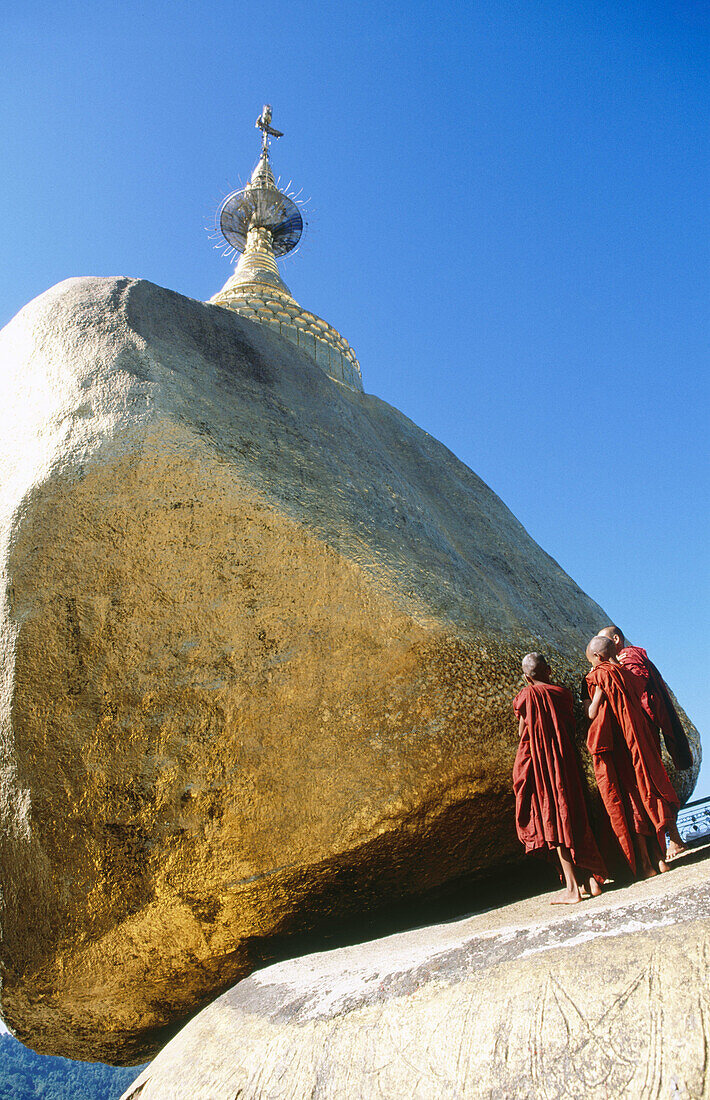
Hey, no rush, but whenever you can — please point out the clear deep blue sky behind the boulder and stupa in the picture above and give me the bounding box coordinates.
[0,0,710,794]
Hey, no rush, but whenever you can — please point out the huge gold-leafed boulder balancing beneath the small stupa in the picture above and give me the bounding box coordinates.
[0,278,699,1063]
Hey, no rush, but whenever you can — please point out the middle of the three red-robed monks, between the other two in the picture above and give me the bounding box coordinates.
[587,636,686,878]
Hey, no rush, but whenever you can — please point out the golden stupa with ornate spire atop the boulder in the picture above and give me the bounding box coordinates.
[210,103,362,391]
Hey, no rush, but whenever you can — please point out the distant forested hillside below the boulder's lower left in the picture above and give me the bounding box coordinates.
[0,1035,143,1100]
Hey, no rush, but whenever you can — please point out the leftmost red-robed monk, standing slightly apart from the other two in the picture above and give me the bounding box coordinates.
[513,653,608,905]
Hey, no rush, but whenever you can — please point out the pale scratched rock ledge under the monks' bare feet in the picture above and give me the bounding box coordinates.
[123,849,710,1100]
